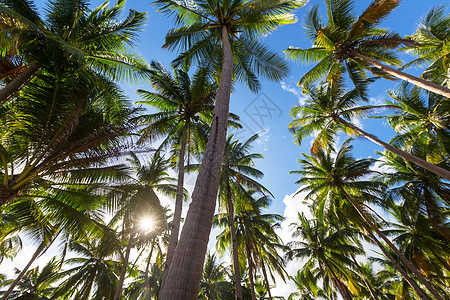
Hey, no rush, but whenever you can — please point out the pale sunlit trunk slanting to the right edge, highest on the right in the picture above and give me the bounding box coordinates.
[351,51,450,98]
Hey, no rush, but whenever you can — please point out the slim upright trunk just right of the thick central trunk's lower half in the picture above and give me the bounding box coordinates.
[227,183,242,300]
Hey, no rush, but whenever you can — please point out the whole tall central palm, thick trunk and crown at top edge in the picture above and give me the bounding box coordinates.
[154,0,304,299]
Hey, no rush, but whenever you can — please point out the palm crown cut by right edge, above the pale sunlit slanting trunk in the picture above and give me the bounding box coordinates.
[403,5,450,87]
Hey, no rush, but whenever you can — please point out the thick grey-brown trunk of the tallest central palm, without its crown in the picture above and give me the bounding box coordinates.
[160,26,233,300]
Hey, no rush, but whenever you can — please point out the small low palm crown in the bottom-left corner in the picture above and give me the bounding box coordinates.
[0,258,61,300]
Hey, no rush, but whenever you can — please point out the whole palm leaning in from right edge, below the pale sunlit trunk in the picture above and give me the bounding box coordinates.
[289,81,450,179]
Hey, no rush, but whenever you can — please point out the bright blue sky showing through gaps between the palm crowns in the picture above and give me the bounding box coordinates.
[4,0,443,296]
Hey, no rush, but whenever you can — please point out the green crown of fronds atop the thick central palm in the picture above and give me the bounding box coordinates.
[154,0,305,91]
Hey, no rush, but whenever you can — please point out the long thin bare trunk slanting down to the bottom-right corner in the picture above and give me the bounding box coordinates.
[340,187,444,300]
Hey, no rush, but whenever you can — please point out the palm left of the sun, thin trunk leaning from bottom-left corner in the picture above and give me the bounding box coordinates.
[2,169,115,300]
